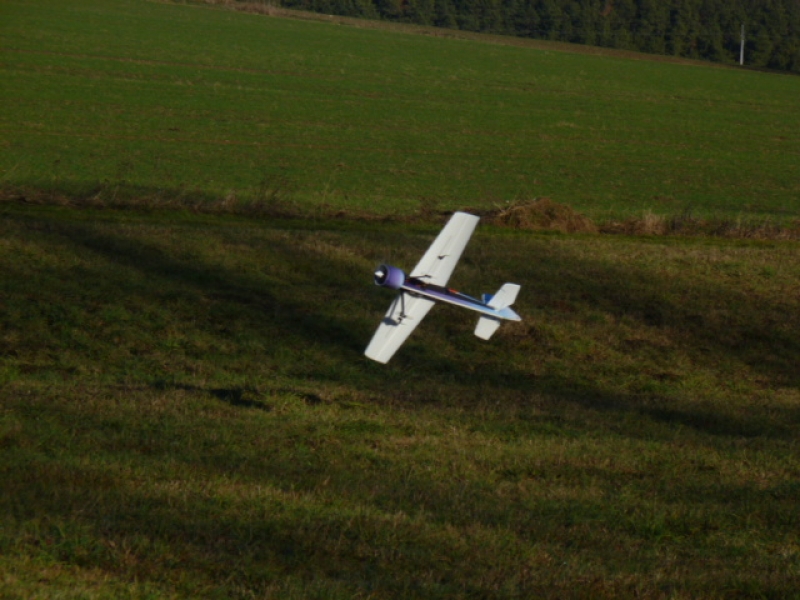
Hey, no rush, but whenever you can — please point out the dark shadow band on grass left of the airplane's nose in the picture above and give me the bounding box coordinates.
[3,206,362,356]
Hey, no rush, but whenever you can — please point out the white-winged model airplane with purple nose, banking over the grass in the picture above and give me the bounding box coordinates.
[364,212,521,363]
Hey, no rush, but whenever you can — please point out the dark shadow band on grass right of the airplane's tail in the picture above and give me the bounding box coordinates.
[526,239,800,388]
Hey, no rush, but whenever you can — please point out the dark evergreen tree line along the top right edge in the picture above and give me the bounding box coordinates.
[279,0,800,72]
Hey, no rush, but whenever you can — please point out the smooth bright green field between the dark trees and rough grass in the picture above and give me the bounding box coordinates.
[0,0,800,221]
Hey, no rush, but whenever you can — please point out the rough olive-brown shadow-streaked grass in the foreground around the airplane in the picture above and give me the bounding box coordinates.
[0,203,800,598]
